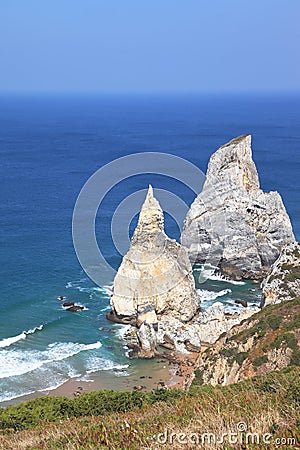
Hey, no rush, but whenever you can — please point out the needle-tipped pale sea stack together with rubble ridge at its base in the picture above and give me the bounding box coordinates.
[107,186,258,358]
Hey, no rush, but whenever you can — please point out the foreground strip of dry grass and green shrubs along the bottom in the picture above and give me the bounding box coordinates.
[0,367,300,450]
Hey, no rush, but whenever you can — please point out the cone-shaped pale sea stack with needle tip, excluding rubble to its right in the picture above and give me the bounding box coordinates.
[107,186,200,358]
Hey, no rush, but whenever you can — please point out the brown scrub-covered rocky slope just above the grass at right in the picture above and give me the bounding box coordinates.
[195,298,300,386]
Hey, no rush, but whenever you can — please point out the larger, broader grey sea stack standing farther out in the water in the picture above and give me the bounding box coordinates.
[181,135,295,279]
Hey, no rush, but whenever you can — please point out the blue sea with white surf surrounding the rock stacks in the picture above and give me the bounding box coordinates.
[0,95,300,402]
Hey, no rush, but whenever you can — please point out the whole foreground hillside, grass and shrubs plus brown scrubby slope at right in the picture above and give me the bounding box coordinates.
[0,297,300,450]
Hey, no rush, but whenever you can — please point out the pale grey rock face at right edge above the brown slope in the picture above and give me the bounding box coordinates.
[262,243,300,305]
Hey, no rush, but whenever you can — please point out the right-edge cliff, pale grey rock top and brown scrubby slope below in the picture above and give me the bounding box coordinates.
[192,243,300,385]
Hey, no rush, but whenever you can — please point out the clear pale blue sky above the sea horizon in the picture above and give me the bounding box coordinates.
[0,0,300,92]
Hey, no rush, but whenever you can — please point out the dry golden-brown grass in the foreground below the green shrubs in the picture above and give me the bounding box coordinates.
[0,369,300,450]
